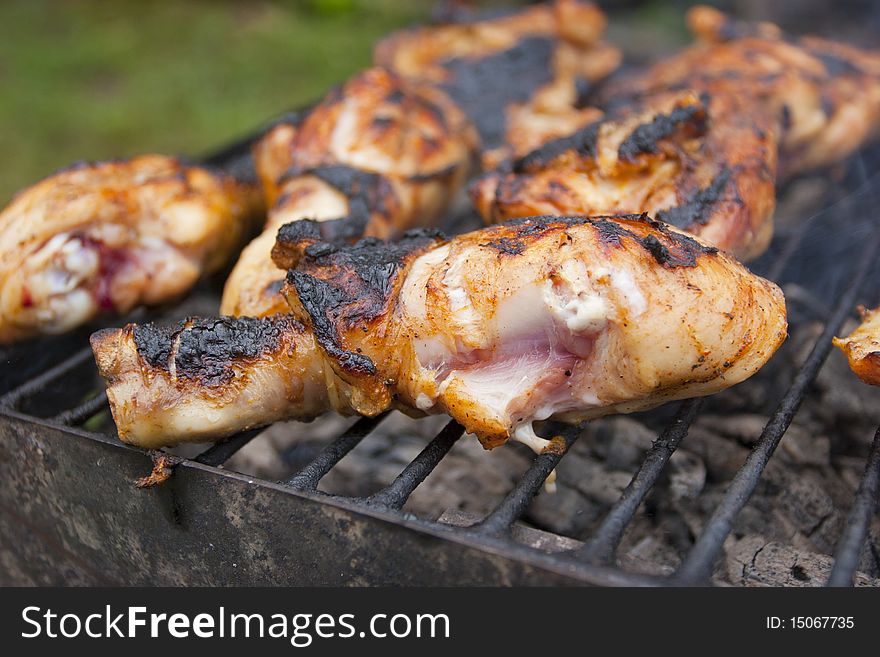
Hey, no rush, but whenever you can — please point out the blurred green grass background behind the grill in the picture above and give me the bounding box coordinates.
[0,0,880,204]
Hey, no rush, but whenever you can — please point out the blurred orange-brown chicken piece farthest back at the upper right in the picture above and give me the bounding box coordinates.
[604,7,880,178]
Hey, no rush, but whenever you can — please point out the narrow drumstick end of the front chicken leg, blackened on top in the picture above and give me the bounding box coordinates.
[91,315,328,448]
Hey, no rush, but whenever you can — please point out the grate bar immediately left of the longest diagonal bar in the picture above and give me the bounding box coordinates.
[576,399,703,564]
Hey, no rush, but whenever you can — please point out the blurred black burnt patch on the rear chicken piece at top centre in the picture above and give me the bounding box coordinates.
[441,36,555,148]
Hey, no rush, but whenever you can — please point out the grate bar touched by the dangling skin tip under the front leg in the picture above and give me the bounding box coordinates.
[471,423,582,536]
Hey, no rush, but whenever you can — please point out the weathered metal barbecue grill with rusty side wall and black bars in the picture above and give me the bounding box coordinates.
[0,7,880,586]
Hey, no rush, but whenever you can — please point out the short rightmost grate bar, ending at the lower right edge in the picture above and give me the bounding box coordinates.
[828,429,880,586]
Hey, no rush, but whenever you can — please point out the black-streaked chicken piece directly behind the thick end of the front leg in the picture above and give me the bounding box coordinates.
[471,92,776,259]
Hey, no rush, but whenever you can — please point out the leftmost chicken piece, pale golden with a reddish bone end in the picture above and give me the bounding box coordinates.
[0,155,263,343]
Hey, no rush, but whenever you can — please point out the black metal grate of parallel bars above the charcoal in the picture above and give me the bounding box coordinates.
[0,129,880,585]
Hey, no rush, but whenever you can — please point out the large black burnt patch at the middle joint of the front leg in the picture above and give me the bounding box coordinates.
[287,228,444,375]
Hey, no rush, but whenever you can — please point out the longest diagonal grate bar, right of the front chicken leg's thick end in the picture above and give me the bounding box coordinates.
[676,230,880,583]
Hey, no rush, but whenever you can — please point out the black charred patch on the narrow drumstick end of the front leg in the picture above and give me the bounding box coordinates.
[133,315,303,386]
